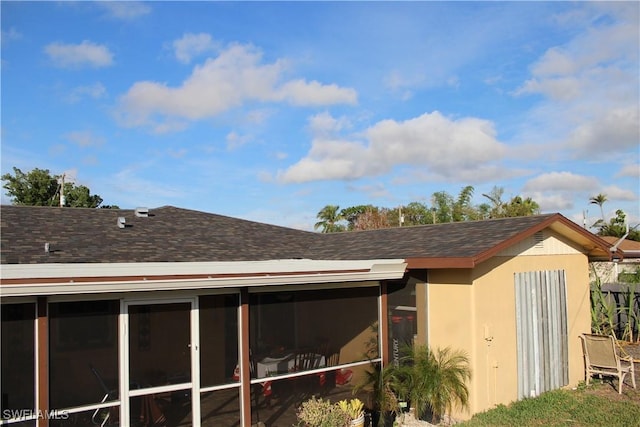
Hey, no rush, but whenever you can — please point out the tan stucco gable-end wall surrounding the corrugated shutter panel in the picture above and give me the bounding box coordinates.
[427,251,590,419]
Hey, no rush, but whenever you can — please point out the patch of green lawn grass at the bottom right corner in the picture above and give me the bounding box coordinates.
[458,384,640,427]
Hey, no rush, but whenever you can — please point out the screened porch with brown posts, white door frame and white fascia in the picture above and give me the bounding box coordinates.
[0,260,404,427]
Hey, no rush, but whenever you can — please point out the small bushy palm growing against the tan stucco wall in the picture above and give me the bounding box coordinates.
[397,345,471,423]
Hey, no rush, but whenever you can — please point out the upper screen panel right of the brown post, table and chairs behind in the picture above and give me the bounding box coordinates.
[249,287,379,378]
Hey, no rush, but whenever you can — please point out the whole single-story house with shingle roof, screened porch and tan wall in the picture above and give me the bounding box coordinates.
[0,206,610,426]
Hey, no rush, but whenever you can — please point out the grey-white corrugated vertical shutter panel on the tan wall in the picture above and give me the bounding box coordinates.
[515,270,569,399]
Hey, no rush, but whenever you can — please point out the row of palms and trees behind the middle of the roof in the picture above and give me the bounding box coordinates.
[314,185,540,233]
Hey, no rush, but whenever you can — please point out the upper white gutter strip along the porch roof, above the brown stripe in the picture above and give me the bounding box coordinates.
[0,259,404,279]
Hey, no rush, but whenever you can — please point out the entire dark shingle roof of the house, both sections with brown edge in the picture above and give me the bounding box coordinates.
[0,206,606,267]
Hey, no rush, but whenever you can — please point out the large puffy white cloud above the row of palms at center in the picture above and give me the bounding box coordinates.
[278,111,506,182]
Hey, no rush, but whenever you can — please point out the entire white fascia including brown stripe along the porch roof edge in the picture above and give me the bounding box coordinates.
[0,260,406,297]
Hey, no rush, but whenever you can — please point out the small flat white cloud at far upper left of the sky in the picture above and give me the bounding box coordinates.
[44,40,113,68]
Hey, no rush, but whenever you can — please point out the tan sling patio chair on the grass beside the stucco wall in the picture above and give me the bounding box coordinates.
[580,334,636,394]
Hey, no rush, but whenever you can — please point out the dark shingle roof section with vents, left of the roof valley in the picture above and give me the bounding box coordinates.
[0,206,318,264]
